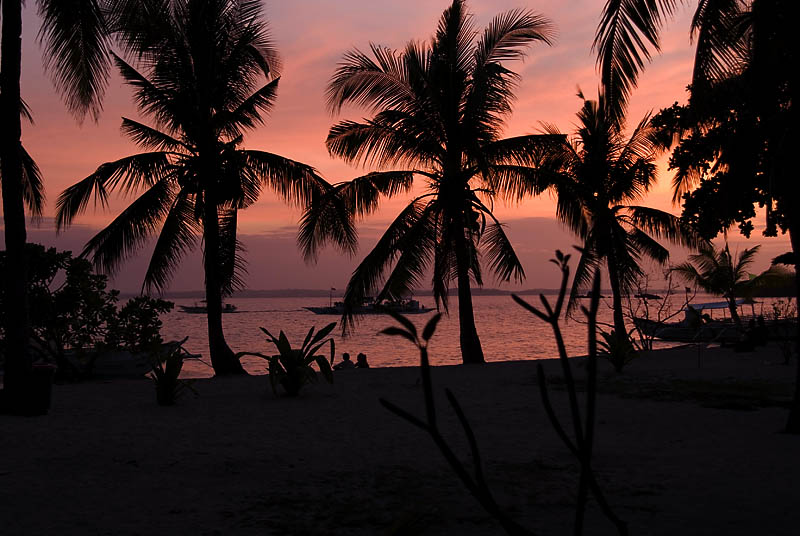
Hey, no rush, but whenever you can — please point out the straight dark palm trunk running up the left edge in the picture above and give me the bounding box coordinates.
[0,0,31,413]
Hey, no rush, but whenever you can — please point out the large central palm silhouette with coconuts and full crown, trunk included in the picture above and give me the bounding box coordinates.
[301,0,551,363]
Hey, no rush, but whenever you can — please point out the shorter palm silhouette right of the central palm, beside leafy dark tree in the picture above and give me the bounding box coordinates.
[542,92,702,337]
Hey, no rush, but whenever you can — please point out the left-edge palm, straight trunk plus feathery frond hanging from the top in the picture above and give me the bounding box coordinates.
[0,0,114,411]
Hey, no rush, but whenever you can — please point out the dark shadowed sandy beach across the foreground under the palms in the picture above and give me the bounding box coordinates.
[0,348,800,535]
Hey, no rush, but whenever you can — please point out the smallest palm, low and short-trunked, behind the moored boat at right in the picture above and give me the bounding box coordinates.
[672,244,760,326]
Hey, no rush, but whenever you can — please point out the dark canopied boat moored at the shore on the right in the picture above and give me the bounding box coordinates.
[633,300,797,344]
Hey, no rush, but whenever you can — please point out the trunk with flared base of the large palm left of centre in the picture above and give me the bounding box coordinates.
[203,194,246,376]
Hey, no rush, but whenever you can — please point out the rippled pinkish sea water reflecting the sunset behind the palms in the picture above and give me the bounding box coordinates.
[162,296,766,377]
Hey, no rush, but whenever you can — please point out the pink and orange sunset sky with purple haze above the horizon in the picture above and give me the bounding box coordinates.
[0,0,789,292]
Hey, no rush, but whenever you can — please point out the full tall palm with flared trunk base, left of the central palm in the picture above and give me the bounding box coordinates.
[57,0,327,375]
